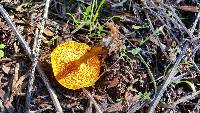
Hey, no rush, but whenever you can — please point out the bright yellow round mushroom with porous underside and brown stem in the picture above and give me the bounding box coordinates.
[51,41,102,90]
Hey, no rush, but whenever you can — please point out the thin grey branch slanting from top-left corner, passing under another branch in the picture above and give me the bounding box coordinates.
[0,4,63,113]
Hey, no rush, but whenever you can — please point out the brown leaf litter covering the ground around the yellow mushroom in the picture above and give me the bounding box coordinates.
[0,0,200,113]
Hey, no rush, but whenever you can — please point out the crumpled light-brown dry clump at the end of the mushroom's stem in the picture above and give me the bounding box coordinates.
[106,22,122,55]
